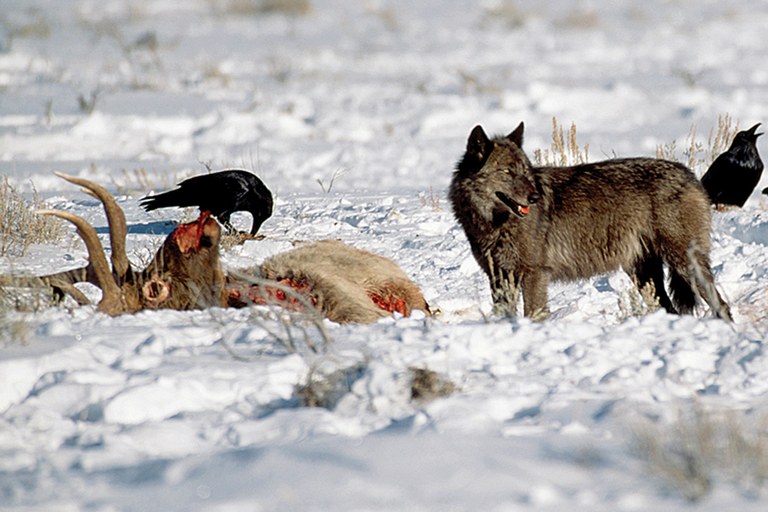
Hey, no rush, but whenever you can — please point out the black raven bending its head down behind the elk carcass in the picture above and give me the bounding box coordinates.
[141,169,272,235]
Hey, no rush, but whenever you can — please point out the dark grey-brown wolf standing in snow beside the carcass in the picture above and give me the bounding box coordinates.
[449,123,731,320]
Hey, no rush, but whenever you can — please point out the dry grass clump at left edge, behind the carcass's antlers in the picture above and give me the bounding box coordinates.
[0,177,67,256]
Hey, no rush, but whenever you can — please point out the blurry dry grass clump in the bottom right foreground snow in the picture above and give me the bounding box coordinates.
[631,405,768,502]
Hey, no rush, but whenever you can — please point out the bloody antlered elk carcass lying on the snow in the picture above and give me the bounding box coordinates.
[0,173,430,323]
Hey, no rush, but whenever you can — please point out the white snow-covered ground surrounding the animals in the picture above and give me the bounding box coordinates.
[0,0,768,511]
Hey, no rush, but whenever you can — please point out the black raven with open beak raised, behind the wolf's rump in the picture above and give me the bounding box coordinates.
[701,123,763,206]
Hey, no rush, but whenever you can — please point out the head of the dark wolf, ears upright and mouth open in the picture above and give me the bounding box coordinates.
[452,123,540,221]
